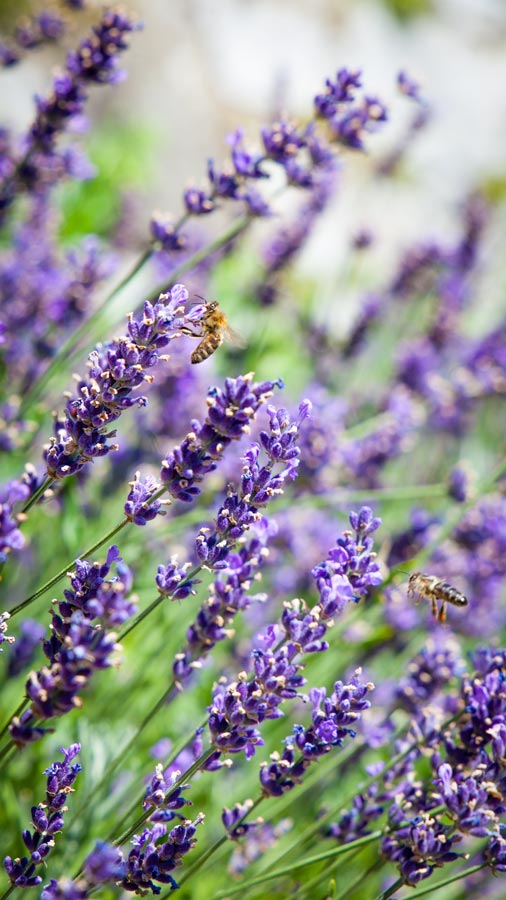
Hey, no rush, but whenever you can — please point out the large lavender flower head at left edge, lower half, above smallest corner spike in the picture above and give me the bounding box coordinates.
[9,547,135,747]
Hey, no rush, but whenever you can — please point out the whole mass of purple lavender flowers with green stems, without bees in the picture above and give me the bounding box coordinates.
[0,7,506,900]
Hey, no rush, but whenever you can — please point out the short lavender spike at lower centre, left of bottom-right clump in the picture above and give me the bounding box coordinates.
[260,670,374,797]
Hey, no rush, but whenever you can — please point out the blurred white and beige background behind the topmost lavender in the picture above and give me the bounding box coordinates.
[1,0,506,296]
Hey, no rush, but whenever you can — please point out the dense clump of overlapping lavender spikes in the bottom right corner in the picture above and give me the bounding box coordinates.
[330,641,506,885]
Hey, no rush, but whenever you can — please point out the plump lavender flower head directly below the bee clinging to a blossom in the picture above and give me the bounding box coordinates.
[160,373,283,503]
